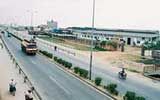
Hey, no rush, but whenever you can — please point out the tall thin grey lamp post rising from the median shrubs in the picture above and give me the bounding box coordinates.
[89,0,95,80]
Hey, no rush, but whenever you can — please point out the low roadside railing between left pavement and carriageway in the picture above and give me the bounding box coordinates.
[1,36,42,100]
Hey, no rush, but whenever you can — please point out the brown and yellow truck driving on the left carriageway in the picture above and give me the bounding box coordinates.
[21,39,38,55]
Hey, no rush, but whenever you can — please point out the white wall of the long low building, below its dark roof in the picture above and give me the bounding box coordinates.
[73,32,158,46]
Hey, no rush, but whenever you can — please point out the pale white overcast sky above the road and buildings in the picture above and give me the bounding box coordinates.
[0,0,160,30]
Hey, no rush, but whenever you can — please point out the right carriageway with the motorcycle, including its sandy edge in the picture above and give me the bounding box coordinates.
[38,36,160,100]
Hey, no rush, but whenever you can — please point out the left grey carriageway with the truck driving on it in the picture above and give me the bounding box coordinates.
[4,34,111,100]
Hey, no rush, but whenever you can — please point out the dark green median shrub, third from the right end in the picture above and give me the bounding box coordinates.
[104,84,118,95]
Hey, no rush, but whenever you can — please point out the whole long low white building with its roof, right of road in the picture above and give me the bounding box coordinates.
[68,27,160,46]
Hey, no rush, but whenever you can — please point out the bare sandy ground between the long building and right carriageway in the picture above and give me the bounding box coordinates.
[86,46,144,73]
